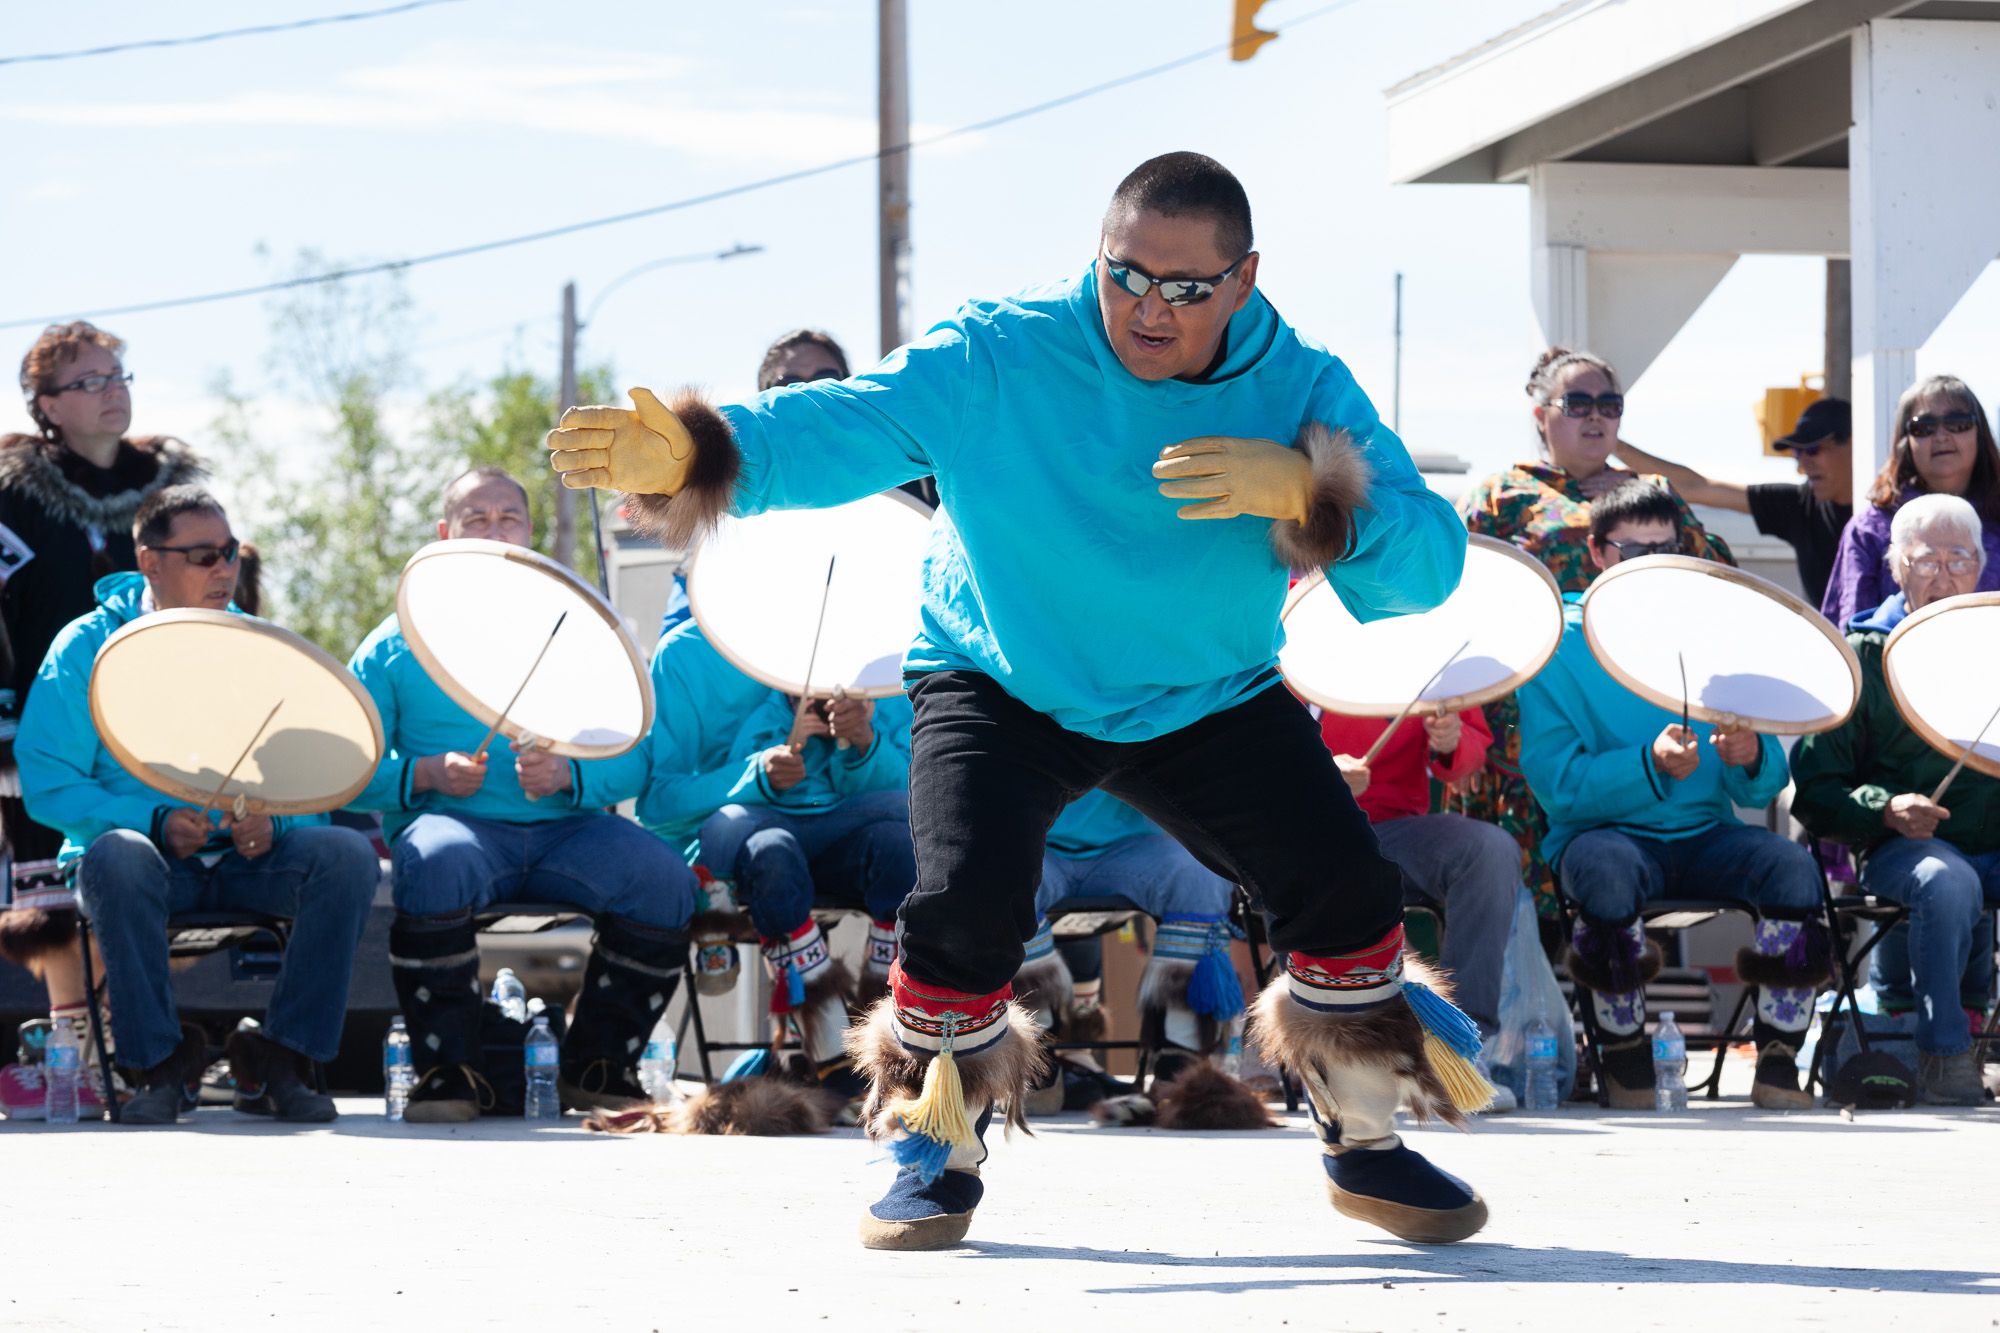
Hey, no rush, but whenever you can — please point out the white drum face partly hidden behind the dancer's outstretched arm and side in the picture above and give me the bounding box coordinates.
[688,492,930,699]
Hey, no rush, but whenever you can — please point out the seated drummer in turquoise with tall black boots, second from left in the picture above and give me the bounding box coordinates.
[348,466,694,1123]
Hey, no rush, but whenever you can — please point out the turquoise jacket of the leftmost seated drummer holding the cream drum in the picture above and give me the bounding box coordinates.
[14,572,326,865]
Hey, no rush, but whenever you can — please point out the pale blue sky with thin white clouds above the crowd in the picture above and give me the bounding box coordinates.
[11,0,2000,512]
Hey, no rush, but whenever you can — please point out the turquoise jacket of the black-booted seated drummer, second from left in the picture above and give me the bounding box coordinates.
[348,614,648,839]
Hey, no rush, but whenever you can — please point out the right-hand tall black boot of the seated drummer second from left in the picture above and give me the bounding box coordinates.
[556,917,688,1111]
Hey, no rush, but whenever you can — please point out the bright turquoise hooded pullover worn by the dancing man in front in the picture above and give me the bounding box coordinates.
[722,260,1466,741]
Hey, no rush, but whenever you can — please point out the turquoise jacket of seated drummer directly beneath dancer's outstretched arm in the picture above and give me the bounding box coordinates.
[638,620,910,861]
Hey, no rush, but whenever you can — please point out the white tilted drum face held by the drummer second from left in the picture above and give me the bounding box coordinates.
[396,540,652,759]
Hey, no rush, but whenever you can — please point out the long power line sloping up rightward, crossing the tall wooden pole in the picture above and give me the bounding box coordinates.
[0,0,1360,328]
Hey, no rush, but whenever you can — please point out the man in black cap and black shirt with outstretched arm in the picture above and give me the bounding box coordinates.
[1608,398,1854,606]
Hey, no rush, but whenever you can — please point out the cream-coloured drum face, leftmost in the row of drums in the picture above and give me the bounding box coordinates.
[90,610,382,815]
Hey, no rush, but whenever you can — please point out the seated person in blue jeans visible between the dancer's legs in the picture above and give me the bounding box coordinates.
[1014,791,1244,1088]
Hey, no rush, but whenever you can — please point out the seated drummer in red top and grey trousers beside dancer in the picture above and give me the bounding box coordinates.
[1320,709,1520,1072]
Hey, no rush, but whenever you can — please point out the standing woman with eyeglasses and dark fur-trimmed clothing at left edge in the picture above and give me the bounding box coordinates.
[0,320,202,1119]
